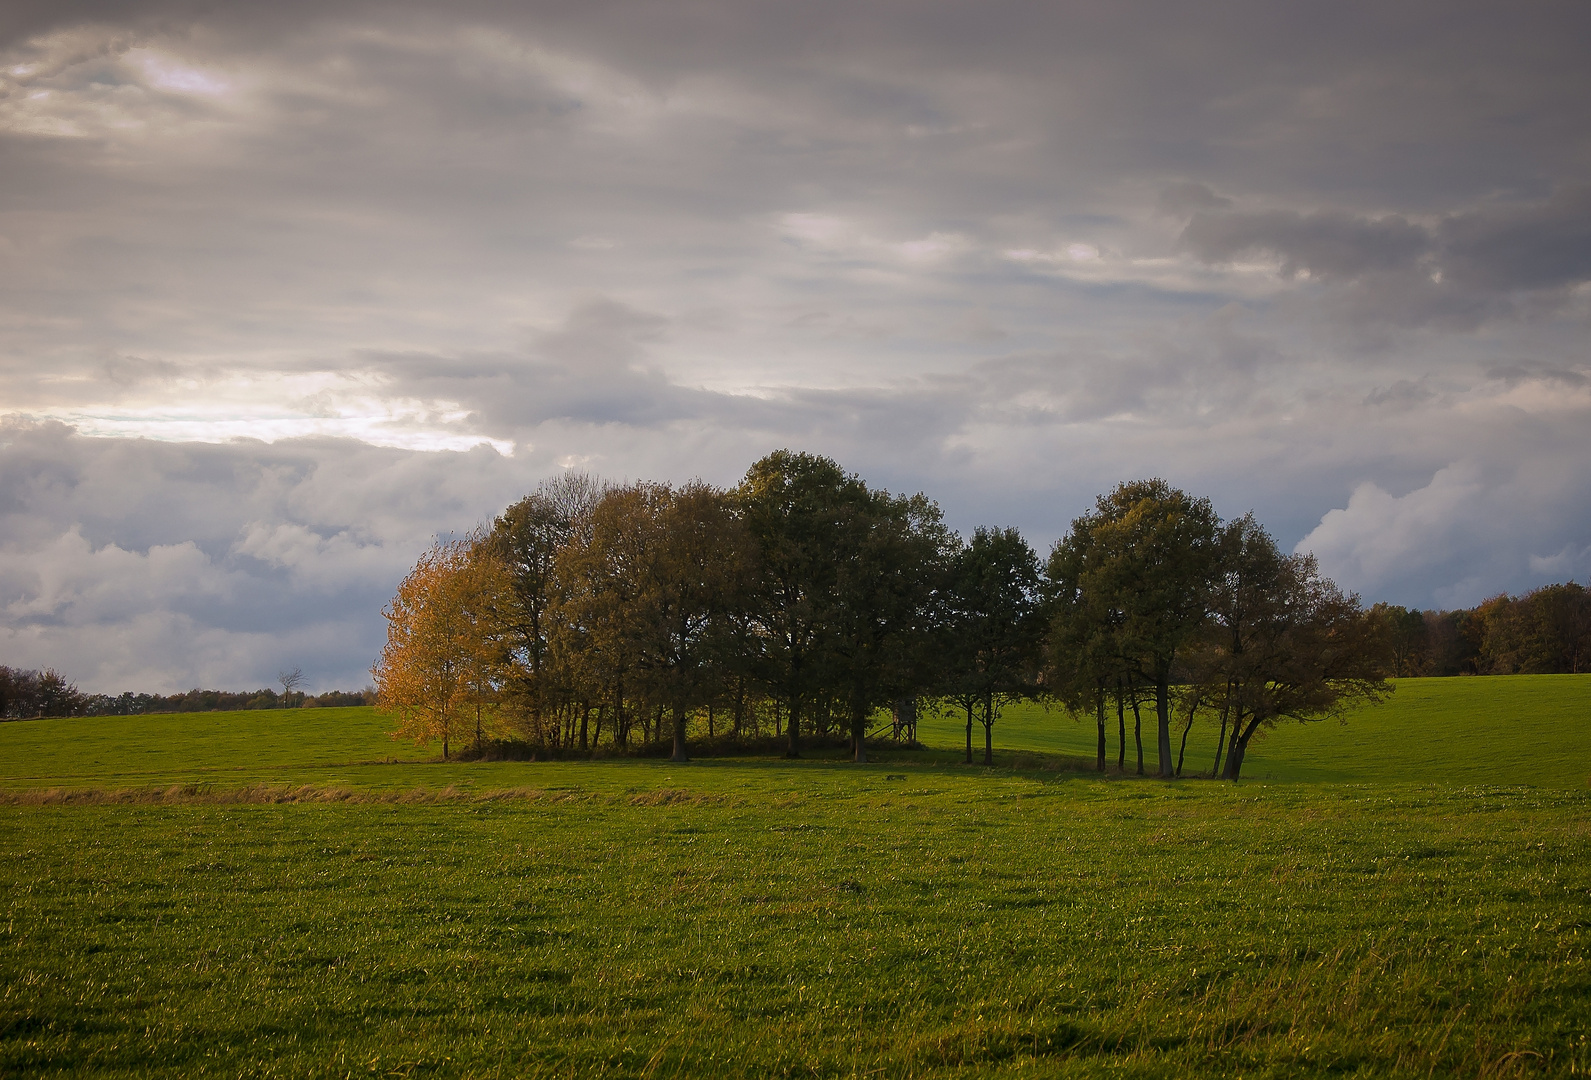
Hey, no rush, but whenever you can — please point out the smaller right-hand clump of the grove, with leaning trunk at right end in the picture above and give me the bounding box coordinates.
[1048,480,1392,779]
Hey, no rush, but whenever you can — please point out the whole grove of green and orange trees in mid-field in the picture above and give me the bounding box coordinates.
[374,450,1389,779]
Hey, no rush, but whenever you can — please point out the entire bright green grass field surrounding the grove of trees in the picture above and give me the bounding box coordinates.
[0,676,1591,1077]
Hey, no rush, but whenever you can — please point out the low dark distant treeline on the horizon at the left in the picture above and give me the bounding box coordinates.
[0,666,375,721]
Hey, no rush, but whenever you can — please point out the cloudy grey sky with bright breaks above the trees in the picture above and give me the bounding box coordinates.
[0,0,1591,692]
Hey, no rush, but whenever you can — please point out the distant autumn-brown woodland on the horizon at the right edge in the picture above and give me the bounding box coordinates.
[1370,581,1591,676]
